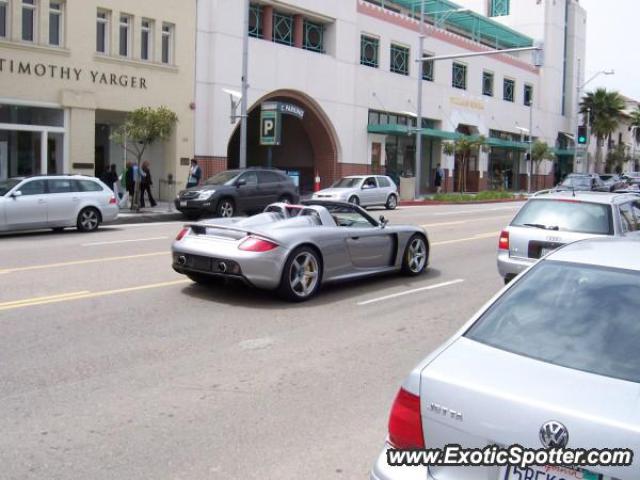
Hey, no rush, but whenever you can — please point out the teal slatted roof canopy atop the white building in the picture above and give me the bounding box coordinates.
[382,0,533,49]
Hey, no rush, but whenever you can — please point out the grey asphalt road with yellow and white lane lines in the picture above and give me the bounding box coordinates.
[0,204,519,480]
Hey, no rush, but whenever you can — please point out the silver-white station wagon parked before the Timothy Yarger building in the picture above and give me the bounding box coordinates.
[0,175,119,232]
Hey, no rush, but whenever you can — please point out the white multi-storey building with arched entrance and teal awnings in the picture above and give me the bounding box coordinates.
[195,0,586,191]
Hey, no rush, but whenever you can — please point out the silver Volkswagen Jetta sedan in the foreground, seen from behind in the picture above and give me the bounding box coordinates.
[371,238,640,480]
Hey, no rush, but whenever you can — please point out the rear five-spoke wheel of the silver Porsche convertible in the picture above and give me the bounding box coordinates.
[279,247,322,302]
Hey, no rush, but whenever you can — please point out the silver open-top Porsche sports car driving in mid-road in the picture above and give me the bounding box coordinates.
[172,200,429,301]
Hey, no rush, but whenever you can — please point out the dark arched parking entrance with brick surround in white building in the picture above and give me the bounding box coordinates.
[227,90,339,193]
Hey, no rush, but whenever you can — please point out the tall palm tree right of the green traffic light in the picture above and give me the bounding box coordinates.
[580,88,625,172]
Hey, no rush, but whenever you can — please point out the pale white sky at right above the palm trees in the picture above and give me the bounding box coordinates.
[580,0,640,100]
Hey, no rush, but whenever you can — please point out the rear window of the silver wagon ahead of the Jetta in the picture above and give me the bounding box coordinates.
[511,199,613,235]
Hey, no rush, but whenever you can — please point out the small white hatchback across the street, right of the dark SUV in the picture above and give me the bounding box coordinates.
[312,175,398,210]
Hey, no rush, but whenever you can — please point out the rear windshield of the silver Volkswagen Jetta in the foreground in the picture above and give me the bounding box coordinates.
[465,261,640,383]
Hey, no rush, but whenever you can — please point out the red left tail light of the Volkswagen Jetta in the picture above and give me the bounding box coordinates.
[389,388,424,449]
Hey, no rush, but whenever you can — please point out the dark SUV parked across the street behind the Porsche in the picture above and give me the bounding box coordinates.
[175,168,299,218]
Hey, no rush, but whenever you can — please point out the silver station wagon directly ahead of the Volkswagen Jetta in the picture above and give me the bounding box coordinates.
[497,191,640,283]
